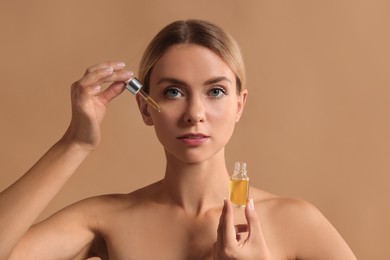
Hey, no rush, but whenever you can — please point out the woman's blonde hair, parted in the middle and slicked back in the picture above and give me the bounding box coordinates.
[138,20,245,93]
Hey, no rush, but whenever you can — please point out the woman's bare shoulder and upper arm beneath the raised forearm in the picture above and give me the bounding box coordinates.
[10,190,140,259]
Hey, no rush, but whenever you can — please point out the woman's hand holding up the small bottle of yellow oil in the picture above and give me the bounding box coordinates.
[213,199,272,260]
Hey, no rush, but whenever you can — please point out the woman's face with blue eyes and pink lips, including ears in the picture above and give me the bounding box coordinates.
[138,44,247,163]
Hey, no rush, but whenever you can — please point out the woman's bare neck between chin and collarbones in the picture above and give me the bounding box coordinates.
[162,151,229,215]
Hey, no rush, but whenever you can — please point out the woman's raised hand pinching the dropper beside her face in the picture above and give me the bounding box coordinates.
[63,62,133,150]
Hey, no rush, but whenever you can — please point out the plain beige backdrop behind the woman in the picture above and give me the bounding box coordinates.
[0,0,390,259]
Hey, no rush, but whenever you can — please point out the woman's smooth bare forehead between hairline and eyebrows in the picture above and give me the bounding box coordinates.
[151,44,235,82]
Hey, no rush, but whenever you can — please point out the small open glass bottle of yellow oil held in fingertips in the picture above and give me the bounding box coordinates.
[229,162,249,208]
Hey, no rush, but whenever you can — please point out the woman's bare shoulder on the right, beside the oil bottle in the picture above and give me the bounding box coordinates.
[251,189,356,259]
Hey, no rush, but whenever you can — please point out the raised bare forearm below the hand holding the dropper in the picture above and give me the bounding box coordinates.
[0,139,88,259]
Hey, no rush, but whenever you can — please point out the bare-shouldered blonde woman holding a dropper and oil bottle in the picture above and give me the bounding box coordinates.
[0,20,355,260]
